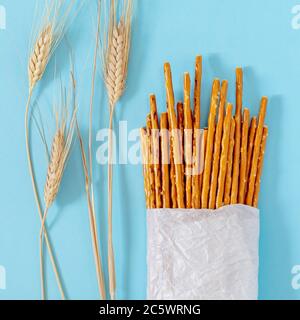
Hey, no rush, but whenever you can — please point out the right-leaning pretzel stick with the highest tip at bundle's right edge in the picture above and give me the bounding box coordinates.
[246,97,268,206]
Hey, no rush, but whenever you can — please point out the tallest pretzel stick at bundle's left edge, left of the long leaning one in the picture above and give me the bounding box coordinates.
[150,94,162,208]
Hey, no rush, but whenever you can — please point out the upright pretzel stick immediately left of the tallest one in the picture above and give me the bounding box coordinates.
[184,73,193,209]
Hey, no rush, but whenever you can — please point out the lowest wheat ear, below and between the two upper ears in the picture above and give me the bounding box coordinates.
[44,129,65,208]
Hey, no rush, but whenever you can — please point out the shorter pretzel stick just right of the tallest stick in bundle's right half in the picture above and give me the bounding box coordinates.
[238,108,250,204]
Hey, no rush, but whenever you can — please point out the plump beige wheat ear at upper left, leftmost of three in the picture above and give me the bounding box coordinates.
[28,25,53,89]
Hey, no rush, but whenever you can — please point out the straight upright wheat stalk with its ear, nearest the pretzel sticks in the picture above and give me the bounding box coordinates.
[103,0,132,300]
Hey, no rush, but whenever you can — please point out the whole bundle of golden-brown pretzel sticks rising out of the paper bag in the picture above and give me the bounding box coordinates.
[140,56,268,209]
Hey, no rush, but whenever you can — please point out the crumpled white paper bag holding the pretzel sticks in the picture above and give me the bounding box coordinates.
[147,205,259,300]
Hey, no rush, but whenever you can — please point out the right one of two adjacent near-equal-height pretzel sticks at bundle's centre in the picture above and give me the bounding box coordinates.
[209,80,227,209]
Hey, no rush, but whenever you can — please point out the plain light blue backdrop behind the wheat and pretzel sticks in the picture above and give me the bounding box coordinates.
[0,0,300,299]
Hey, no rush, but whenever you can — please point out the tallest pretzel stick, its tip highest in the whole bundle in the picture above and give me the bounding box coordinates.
[192,56,202,209]
